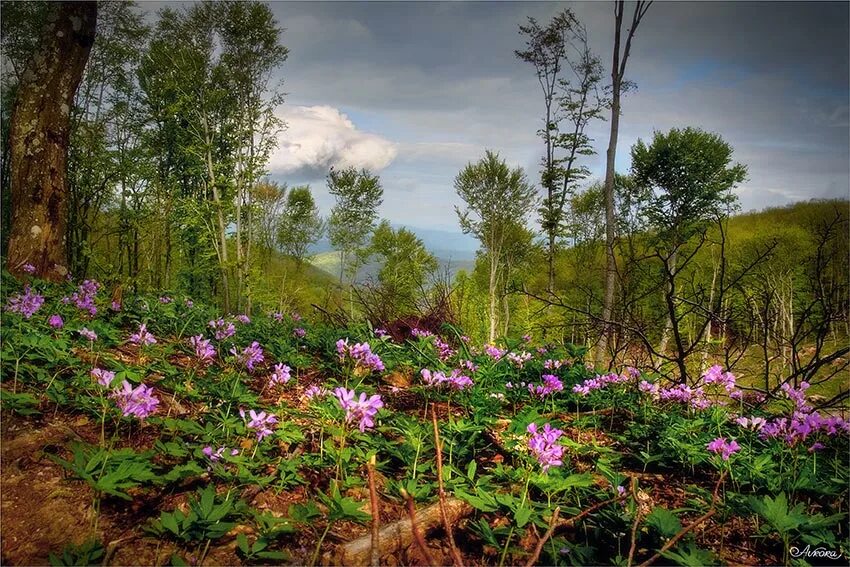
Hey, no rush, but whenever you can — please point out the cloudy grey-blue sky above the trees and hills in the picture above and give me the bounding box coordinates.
[167,1,850,236]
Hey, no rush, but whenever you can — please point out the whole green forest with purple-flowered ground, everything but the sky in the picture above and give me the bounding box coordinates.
[0,0,850,567]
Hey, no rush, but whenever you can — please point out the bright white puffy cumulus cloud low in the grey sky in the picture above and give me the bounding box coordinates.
[269,106,398,175]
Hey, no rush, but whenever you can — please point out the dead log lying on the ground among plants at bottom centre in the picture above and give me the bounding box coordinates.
[332,498,472,565]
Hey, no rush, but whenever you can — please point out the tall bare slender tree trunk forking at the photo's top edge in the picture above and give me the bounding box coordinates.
[595,0,652,366]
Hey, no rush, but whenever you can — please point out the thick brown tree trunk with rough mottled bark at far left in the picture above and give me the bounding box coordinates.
[8,2,97,281]
